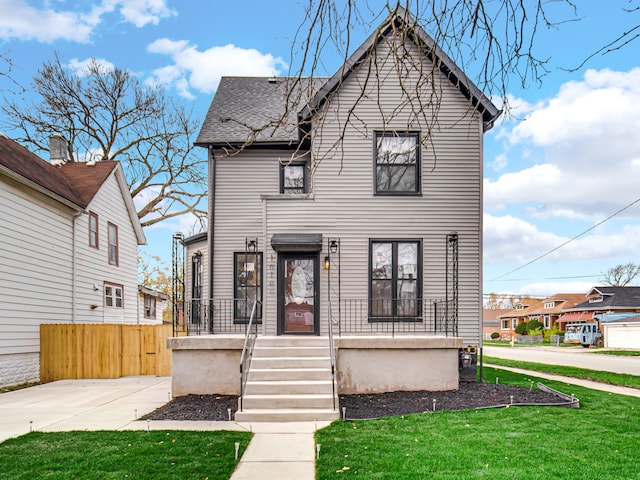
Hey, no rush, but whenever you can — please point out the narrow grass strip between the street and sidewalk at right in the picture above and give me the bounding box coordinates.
[484,357,640,388]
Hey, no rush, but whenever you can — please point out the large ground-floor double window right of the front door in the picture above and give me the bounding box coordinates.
[369,240,422,321]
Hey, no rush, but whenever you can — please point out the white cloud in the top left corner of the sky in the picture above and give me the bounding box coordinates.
[0,0,176,43]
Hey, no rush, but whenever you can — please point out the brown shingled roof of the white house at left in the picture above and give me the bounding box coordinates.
[0,134,146,245]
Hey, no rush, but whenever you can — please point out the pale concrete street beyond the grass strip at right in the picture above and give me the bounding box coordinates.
[482,346,640,375]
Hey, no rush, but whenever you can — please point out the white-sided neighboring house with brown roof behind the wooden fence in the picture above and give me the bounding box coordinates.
[0,135,145,385]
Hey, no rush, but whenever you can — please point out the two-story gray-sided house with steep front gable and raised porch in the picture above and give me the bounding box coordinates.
[170,8,500,418]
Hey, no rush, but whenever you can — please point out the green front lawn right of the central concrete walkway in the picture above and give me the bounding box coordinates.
[316,367,640,480]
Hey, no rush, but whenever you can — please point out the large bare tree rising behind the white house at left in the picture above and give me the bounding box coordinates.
[0,54,207,227]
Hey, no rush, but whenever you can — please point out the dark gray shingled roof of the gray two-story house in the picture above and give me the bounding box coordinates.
[195,6,501,147]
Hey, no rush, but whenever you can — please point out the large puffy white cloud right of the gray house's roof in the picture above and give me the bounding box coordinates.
[484,68,640,220]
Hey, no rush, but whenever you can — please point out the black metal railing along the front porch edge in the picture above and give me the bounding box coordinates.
[181,299,458,337]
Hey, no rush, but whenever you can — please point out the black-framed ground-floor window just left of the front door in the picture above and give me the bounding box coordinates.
[234,252,262,322]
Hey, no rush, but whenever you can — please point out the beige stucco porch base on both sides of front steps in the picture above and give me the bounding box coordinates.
[167,335,463,397]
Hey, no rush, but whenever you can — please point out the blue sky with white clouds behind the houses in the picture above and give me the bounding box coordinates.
[0,0,640,296]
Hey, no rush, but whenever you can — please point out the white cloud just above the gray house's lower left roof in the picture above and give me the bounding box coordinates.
[147,38,287,98]
